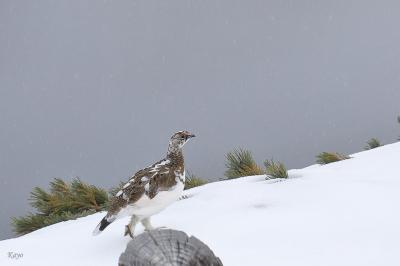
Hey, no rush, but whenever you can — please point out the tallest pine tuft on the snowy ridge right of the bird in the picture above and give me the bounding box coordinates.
[225,149,264,179]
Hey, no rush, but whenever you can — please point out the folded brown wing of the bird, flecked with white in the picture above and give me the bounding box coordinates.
[107,159,173,216]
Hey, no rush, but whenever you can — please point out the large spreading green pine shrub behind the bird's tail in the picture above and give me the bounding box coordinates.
[11,178,108,235]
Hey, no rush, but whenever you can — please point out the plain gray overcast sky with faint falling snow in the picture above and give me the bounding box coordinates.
[0,0,400,238]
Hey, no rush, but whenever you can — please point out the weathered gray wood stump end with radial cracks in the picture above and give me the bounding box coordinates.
[119,229,222,266]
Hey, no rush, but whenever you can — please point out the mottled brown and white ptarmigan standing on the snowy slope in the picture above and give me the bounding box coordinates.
[93,131,195,237]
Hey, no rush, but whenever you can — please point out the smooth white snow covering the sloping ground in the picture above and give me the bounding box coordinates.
[0,143,400,266]
